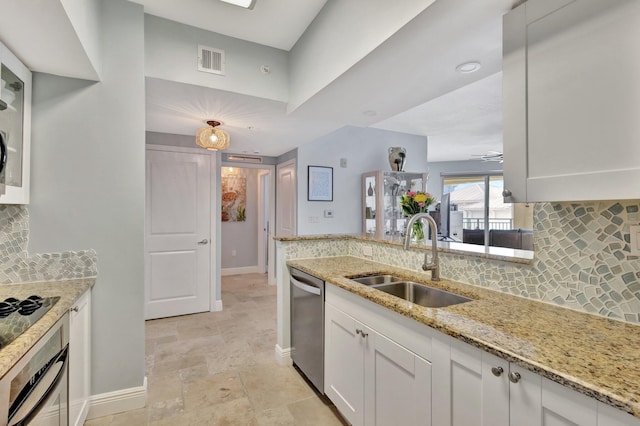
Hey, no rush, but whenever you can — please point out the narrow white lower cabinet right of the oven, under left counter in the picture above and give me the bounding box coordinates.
[69,290,91,426]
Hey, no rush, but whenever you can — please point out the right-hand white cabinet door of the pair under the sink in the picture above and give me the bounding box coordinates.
[361,328,431,426]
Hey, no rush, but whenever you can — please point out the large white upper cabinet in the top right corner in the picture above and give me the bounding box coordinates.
[503,0,640,202]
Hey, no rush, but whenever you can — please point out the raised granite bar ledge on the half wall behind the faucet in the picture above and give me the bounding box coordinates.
[273,234,533,265]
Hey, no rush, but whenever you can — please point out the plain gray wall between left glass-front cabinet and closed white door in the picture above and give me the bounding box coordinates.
[29,0,145,394]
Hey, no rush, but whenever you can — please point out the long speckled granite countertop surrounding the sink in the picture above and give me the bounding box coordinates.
[287,256,640,418]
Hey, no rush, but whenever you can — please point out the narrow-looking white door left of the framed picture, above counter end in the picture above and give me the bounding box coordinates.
[276,160,297,236]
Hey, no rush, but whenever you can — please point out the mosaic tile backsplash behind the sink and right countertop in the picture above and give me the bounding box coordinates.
[287,200,640,323]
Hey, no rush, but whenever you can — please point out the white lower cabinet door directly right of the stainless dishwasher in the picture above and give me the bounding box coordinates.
[324,303,366,426]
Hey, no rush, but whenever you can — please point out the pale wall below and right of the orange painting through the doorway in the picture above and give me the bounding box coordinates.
[221,167,259,268]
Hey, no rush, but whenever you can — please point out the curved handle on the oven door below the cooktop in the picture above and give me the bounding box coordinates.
[8,345,69,426]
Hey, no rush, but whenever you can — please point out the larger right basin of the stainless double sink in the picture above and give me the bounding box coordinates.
[373,281,473,308]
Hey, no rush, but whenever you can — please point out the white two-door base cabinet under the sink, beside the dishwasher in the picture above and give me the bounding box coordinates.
[325,286,431,426]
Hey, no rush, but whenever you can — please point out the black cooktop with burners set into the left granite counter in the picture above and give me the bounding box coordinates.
[0,295,60,349]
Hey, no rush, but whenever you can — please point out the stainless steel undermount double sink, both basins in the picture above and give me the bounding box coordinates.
[350,275,473,308]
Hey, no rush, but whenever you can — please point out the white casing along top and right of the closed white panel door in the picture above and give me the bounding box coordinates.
[145,144,222,312]
